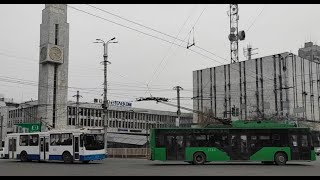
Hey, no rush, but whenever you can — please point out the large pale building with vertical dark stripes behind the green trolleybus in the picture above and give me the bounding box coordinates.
[193,52,320,129]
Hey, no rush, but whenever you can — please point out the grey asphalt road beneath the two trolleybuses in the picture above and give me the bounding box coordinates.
[0,157,320,176]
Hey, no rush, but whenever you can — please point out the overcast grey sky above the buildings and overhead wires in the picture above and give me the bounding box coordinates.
[0,4,320,111]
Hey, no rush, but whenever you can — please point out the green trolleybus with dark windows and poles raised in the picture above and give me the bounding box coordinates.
[150,121,316,165]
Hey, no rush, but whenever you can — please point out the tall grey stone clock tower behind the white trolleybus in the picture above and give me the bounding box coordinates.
[37,4,69,130]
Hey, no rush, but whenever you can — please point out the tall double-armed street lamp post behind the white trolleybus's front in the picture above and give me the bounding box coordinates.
[94,37,118,154]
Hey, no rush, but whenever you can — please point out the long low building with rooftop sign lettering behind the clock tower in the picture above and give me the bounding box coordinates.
[7,101,192,147]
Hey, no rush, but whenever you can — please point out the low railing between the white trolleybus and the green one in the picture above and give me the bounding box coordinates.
[108,148,150,159]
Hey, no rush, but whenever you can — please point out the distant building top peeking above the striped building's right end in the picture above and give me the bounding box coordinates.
[298,42,320,63]
